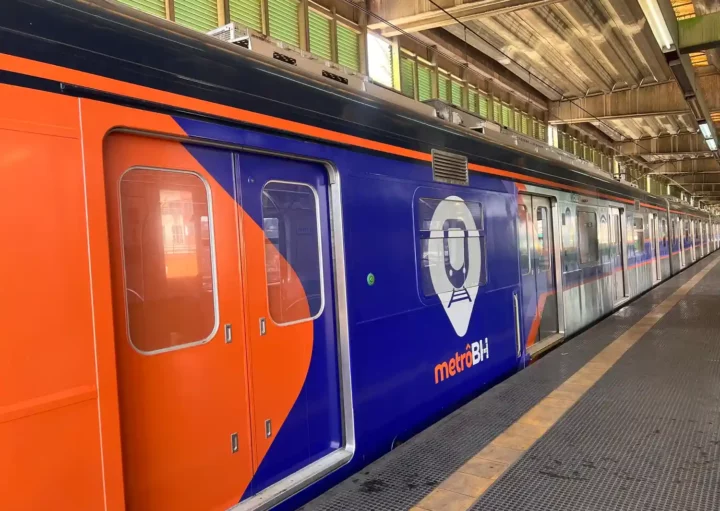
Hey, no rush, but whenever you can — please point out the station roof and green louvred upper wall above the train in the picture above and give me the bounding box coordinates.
[109,0,720,208]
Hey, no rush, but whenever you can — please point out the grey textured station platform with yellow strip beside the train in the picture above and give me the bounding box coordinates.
[303,253,720,511]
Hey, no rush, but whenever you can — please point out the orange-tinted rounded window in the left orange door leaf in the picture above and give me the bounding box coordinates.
[120,168,218,354]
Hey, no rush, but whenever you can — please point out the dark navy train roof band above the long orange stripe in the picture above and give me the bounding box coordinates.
[0,0,707,218]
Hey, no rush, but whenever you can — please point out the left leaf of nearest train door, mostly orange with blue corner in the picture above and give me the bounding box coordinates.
[104,134,252,511]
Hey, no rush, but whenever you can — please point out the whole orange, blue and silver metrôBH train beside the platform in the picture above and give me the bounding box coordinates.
[0,0,720,511]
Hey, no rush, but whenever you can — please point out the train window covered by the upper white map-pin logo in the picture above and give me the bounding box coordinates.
[417,197,487,302]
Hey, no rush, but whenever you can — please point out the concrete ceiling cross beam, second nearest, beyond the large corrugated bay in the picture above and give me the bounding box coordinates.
[550,81,690,124]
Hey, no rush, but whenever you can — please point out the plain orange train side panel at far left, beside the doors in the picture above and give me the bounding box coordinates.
[0,85,104,511]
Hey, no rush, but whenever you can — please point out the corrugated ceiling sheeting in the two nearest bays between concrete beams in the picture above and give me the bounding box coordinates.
[446,0,696,140]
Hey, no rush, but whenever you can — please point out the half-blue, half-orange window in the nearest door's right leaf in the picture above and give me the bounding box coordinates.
[262,181,325,325]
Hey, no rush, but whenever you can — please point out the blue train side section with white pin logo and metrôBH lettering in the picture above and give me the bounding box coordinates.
[176,118,522,509]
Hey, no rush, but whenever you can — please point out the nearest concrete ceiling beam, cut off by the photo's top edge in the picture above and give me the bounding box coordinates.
[368,0,562,37]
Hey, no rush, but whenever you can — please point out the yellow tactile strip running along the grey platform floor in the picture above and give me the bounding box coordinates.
[411,259,720,511]
